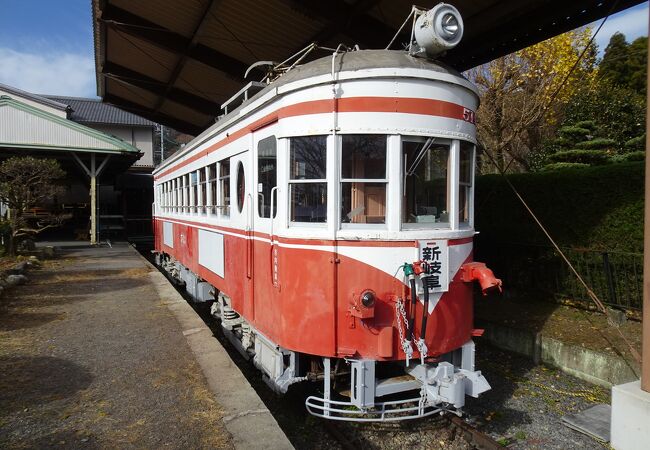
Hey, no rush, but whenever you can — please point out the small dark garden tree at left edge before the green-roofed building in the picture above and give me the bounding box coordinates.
[0,156,65,255]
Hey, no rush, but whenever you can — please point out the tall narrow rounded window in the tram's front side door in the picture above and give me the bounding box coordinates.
[257,136,278,218]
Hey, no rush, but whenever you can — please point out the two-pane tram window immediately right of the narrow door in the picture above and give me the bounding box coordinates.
[289,136,327,223]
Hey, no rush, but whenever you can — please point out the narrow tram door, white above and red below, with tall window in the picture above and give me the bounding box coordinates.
[253,125,280,330]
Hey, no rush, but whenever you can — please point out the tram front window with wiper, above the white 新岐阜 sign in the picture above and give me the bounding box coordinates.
[402,138,450,228]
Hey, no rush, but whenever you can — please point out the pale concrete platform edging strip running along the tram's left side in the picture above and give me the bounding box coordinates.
[133,249,294,449]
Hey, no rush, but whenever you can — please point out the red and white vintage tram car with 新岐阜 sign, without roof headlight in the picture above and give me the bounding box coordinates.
[154,3,500,420]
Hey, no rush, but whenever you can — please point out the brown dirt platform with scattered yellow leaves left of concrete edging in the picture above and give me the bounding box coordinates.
[0,247,232,449]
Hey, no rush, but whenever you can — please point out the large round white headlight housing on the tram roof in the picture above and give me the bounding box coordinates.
[414,3,464,58]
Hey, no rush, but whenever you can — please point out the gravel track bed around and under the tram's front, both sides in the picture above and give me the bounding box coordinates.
[190,298,610,450]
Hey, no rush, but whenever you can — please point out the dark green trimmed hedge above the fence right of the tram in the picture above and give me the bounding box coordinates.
[476,161,644,252]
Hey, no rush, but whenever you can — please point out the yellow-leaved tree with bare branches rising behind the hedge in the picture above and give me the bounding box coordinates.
[468,28,596,173]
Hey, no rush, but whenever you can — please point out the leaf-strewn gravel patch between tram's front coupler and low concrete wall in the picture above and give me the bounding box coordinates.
[465,341,611,450]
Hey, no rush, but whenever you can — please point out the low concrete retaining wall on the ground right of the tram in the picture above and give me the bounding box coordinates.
[478,321,639,387]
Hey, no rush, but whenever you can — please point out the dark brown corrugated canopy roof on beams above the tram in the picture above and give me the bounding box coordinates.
[92,0,642,134]
